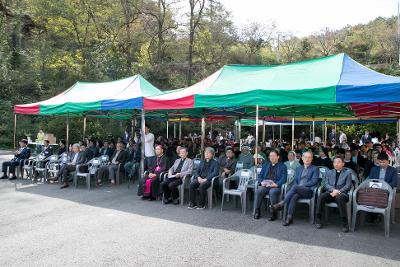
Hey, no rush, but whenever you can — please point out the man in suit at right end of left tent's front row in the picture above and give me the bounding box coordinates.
[97,142,129,186]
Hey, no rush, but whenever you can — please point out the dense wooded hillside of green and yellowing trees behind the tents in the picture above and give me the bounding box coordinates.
[0,0,400,147]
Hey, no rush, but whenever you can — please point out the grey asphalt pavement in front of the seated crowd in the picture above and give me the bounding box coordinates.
[0,152,400,267]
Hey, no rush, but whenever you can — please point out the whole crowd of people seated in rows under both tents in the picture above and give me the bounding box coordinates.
[1,126,397,232]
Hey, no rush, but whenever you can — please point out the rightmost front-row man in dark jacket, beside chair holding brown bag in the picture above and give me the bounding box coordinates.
[316,157,352,233]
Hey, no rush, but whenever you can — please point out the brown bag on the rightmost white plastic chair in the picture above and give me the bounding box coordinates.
[357,187,389,209]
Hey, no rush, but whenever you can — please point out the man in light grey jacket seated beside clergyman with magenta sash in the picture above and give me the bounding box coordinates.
[161,147,193,205]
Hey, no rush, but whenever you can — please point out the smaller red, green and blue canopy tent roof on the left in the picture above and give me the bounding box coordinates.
[14,75,163,116]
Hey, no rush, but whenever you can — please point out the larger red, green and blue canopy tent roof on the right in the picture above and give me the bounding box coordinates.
[144,54,400,116]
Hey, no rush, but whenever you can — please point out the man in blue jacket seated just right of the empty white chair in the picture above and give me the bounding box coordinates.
[254,150,287,221]
